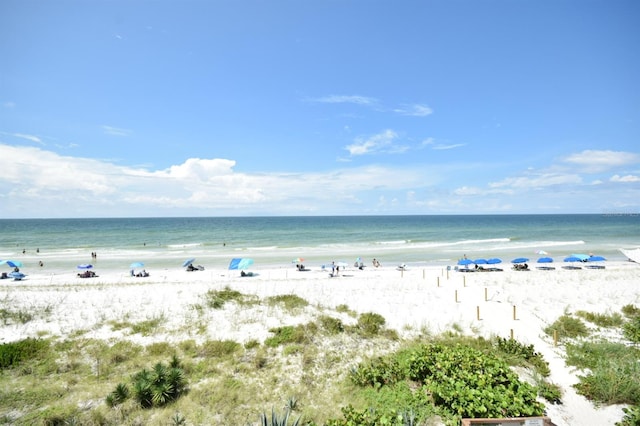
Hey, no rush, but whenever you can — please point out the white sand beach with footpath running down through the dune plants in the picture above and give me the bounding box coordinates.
[0,262,640,426]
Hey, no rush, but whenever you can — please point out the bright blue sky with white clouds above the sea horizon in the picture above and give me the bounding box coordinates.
[0,0,640,218]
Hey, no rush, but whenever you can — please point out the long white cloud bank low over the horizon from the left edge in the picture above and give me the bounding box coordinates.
[0,144,428,217]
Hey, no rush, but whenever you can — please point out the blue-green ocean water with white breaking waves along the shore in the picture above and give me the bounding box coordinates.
[0,215,640,270]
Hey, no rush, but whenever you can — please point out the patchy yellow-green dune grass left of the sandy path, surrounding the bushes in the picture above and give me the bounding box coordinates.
[0,291,616,425]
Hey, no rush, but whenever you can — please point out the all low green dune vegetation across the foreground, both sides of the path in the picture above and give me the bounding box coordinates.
[0,288,640,426]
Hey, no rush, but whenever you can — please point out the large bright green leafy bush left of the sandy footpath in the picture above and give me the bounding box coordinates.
[351,344,544,419]
